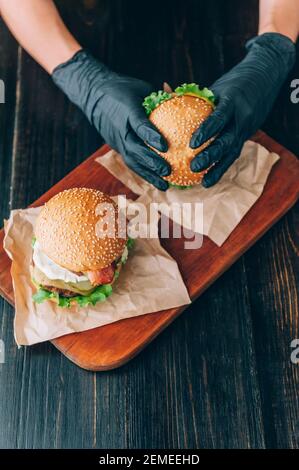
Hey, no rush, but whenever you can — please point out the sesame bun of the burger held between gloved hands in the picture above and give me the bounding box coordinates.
[149,94,213,186]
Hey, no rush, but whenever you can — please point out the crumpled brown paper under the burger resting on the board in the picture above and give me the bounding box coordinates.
[4,208,190,345]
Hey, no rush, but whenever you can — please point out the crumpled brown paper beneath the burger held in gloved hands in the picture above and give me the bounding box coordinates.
[97,141,279,246]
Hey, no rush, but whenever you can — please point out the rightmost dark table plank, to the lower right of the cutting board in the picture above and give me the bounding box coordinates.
[244,134,299,442]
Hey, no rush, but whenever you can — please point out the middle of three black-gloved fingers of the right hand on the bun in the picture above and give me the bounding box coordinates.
[190,129,236,172]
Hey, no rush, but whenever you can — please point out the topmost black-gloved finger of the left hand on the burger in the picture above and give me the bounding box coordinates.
[129,106,168,152]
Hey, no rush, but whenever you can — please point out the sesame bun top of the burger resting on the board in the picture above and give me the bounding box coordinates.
[35,188,127,272]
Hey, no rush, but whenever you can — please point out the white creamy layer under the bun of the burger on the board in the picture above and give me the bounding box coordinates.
[33,240,88,283]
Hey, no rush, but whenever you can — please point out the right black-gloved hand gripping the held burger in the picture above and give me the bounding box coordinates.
[190,33,296,187]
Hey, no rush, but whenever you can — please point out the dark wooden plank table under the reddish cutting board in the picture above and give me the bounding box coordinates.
[0,0,299,448]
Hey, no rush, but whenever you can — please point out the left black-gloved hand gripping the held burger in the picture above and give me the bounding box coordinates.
[52,50,171,191]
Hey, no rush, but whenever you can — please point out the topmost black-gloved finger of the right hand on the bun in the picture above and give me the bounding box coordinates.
[190,99,233,149]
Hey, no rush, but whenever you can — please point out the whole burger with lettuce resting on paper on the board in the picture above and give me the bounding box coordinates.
[31,188,133,307]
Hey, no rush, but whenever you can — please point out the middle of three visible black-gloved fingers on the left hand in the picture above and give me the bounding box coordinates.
[126,132,171,176]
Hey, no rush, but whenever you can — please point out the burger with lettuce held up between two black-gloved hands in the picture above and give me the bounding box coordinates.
[143,83,215,189]
